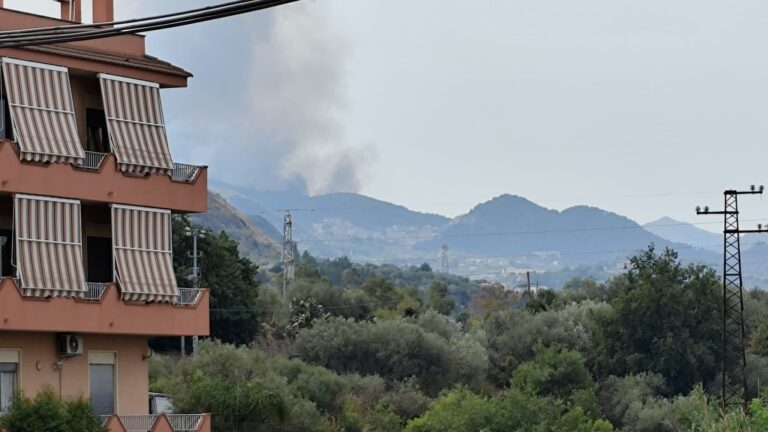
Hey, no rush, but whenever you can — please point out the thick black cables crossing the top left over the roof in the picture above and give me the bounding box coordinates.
[0,0,299,48]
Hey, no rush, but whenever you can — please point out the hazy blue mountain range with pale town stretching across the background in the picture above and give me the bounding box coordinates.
[202,182,720,280]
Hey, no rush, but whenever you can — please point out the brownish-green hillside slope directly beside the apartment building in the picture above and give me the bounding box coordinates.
[192,191,280,264]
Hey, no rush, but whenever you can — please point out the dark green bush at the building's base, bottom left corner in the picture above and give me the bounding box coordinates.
[0,389,106,432]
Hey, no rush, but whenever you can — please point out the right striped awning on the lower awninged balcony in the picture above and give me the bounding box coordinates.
[112,204,179,302]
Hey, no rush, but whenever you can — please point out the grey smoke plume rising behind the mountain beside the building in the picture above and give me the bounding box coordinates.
[124,0,369,194]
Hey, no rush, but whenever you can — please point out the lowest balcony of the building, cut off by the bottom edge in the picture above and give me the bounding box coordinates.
[101,414,211,432]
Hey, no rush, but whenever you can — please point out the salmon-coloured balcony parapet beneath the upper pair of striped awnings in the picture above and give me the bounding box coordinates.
[0,140,208,213]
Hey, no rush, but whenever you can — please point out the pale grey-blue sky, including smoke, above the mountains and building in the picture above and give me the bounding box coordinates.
[5,0,768,230]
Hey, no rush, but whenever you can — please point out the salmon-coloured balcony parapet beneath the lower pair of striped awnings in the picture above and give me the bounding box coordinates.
[0,278,210,336]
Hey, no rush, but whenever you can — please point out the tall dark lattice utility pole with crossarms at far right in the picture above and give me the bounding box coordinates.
[696,185,768,412]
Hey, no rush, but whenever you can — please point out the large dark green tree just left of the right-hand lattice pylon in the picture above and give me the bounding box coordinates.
[598,246,720,393]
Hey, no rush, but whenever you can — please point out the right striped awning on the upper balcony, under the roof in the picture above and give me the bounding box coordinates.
[99,74,173,174]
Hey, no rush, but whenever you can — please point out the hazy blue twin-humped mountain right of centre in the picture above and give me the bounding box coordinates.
[420,195,713,265]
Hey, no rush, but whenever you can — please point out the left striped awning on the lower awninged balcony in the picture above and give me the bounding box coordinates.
[14,195,86,297]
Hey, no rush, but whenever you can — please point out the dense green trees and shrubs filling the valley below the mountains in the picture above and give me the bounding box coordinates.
[151,219,768,432]
